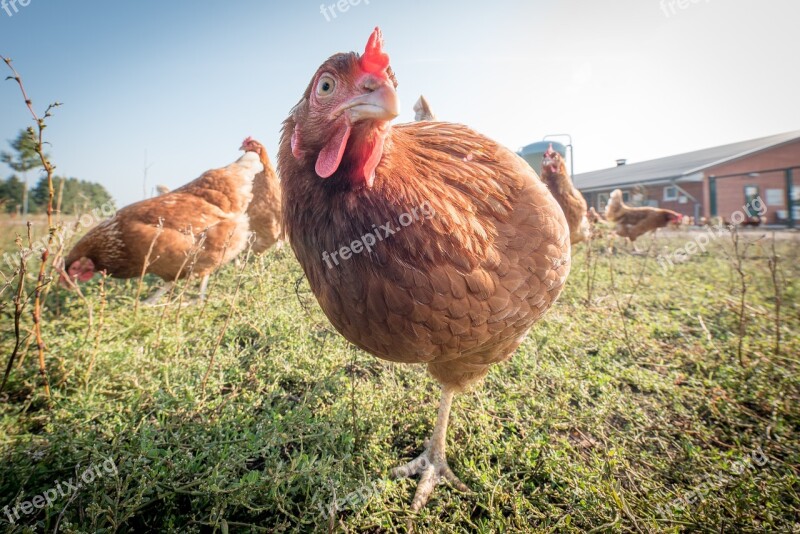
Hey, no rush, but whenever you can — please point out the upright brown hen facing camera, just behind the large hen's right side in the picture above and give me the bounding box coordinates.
[542,145,591,245]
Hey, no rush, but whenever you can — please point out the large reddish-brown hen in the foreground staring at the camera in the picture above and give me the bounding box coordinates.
[278,28,570,511]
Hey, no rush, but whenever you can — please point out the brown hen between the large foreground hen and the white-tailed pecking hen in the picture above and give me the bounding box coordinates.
[244,137,281,254]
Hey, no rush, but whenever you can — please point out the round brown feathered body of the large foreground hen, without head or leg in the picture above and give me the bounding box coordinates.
[284,123,570,382]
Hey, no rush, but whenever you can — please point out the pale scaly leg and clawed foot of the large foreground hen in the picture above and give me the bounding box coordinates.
[392,386,469,512]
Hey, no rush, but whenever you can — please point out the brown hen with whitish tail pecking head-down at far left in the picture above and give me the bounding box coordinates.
[62,139,264,304]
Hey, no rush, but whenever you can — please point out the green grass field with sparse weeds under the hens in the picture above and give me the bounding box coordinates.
[0,220,800,533]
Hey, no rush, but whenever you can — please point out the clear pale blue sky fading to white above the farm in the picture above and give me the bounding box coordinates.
[0,0,800,204]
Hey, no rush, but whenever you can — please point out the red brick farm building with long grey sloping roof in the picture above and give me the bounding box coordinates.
[574,130,800,227]
